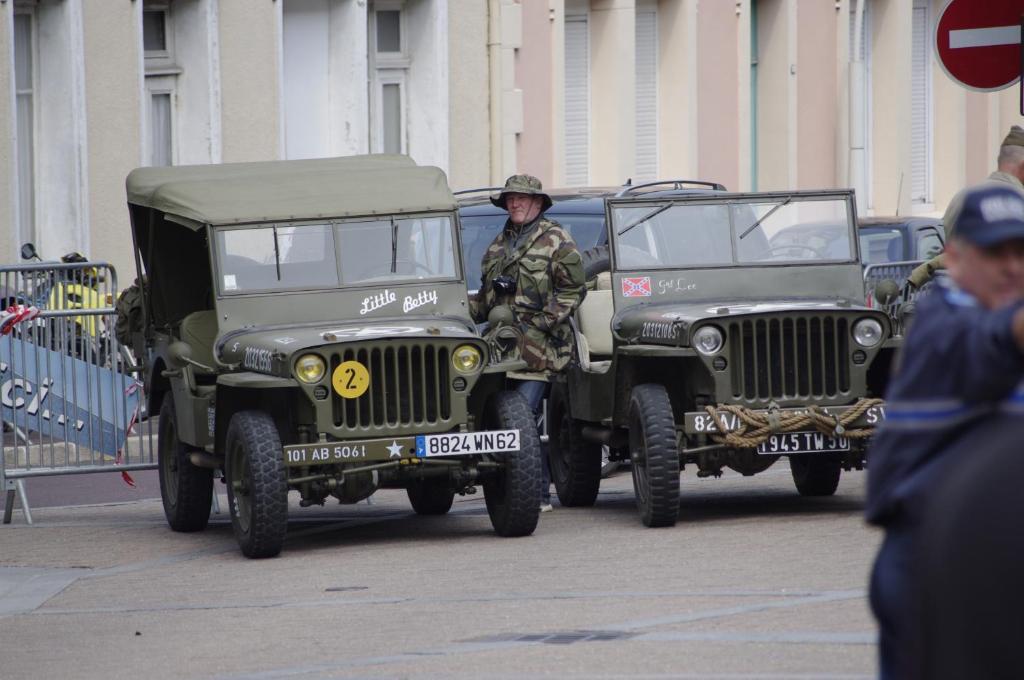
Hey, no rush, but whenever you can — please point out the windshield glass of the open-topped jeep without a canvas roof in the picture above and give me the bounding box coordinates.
[611,196,856,269]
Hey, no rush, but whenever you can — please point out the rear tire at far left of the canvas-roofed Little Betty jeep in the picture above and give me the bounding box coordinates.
[157,399,213,532]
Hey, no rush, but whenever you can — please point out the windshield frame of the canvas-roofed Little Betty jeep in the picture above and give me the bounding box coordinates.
[208,210,464,299]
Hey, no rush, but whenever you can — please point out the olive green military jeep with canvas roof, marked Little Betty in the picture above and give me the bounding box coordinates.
[127,156,541,557]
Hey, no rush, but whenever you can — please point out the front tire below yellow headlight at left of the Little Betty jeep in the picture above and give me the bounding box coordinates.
[224,411,288,557]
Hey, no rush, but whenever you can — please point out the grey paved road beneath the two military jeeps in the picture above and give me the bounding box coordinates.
[0,462,881,679]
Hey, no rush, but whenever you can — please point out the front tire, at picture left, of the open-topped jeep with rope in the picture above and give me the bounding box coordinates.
[630,384,679,526]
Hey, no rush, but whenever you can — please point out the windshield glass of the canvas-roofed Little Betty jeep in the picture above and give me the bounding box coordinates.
[216,215,457,295]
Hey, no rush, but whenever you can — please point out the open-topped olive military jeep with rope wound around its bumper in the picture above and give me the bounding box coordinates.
[548,192,897,526]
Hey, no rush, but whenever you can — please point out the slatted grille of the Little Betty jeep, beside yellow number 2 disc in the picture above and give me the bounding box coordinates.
[331,343,452,430]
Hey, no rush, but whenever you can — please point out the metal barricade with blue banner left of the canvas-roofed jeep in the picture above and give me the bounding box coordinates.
[0,262,157,524]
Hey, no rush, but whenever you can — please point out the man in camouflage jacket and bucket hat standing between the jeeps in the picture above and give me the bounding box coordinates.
[471,175,587,377]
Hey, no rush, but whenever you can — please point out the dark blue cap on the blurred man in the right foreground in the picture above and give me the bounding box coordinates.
[953,186,1024,248]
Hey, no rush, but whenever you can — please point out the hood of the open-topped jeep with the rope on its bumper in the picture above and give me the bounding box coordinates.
[611,298,888,346]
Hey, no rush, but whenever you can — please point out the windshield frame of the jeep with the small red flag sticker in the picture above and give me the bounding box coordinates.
[605,189,860,272]
